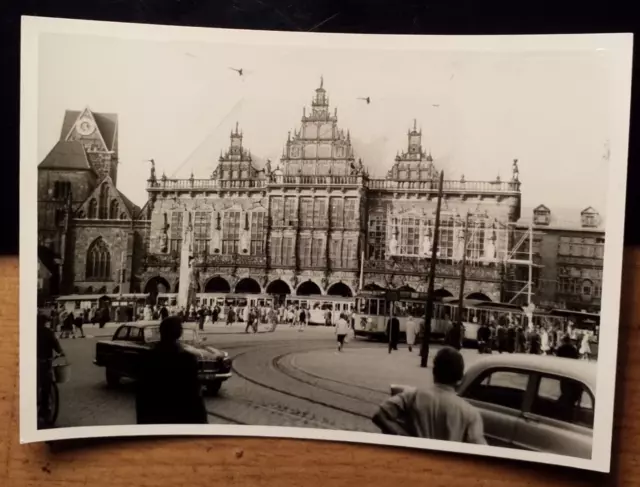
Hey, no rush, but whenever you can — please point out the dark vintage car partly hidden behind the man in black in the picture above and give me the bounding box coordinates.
[93,321,231,395]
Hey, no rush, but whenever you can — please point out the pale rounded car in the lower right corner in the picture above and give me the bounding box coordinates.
[391,354,596,458]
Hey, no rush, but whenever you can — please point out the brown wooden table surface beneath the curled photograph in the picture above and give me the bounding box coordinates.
[0,255,640,487]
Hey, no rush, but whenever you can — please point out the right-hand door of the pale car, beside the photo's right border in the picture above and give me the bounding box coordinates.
[513,374,595,458]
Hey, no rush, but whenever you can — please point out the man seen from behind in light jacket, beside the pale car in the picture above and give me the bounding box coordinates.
[372,347,486,445]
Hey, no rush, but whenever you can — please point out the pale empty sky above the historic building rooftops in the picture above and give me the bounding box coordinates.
[37,34,613,216]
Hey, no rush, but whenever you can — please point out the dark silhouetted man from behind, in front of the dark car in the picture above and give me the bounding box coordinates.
[136,316,208,424]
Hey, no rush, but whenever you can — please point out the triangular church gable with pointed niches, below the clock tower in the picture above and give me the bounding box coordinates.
[76,176,138,220]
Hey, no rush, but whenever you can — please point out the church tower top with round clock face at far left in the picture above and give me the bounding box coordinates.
[60,107,118,184]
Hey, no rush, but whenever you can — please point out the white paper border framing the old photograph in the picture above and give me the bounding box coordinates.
[20,17,633,472]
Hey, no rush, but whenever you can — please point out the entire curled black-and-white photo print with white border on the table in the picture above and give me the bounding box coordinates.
[20,18,632,471]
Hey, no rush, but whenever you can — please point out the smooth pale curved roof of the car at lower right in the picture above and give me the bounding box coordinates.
[465,353,597,391]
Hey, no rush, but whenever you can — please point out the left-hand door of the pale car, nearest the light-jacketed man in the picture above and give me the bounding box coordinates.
[460,367,531,447]
